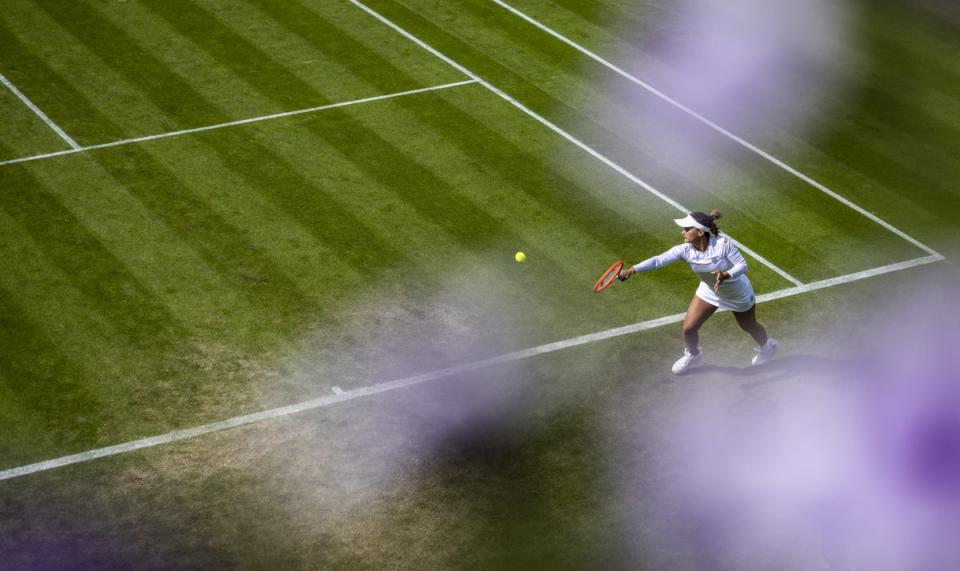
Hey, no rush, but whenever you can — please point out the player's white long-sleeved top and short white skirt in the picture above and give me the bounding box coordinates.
[633,234,756,311]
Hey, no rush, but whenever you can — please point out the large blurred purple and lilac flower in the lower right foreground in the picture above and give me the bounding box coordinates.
[624,287,960,570]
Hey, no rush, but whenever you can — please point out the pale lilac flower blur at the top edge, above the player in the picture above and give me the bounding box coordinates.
[617,0,854,168]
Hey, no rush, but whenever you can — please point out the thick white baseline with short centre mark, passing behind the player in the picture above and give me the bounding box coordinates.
[0,252,942,480]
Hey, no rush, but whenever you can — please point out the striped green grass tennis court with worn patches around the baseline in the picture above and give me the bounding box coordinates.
[0,0,960,569]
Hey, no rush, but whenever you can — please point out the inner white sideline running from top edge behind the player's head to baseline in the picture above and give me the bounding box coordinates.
[350,0,803,286]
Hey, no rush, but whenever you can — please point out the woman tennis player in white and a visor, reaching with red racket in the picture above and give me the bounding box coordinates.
[619,210,777,374]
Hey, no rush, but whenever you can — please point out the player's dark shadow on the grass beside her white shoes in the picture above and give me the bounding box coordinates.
[682,355,858,390]
